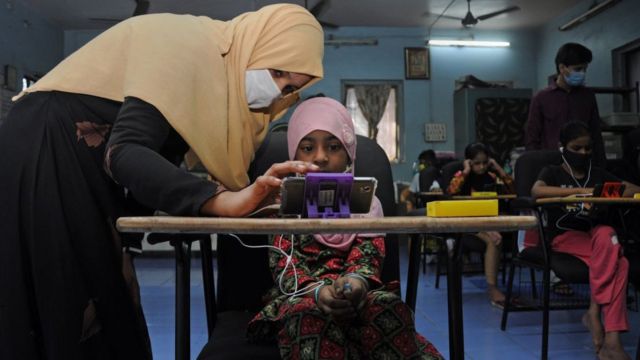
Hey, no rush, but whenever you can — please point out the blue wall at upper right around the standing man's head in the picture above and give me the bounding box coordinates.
[536,0,640,115]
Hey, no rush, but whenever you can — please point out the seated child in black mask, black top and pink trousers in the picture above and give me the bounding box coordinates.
[531,122,640,359]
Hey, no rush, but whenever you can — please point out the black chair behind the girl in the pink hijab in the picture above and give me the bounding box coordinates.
[198,132,400,359]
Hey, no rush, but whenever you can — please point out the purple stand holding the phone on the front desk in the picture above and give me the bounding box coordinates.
[304,173,353,218]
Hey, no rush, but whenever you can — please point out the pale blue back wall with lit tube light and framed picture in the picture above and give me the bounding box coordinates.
[64,27,536,181]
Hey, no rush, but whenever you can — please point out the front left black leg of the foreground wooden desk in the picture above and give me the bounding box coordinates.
[174,241,191,360]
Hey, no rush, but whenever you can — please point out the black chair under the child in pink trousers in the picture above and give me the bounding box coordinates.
[500,150,590,359]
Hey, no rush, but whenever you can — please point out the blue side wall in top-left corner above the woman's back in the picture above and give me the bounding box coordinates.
[0,1,63,88]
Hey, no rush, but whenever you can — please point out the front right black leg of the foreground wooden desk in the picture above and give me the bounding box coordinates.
[447,238,464,360]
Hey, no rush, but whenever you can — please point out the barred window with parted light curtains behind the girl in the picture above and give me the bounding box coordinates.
[343,81,401,162]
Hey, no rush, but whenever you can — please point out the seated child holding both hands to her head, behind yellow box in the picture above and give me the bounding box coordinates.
[447,143,515,307]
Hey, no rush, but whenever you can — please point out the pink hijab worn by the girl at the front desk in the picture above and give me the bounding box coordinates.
[287,97,384,251]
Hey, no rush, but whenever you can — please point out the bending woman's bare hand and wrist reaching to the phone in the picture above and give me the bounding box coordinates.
[200,161,320,217]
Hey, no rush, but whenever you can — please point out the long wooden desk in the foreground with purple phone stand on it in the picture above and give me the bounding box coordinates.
[116,216,537,360]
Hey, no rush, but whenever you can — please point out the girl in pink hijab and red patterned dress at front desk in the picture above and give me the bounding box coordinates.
[249,97,442,359]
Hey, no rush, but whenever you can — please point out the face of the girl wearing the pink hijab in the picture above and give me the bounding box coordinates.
[295,130,350,173]
